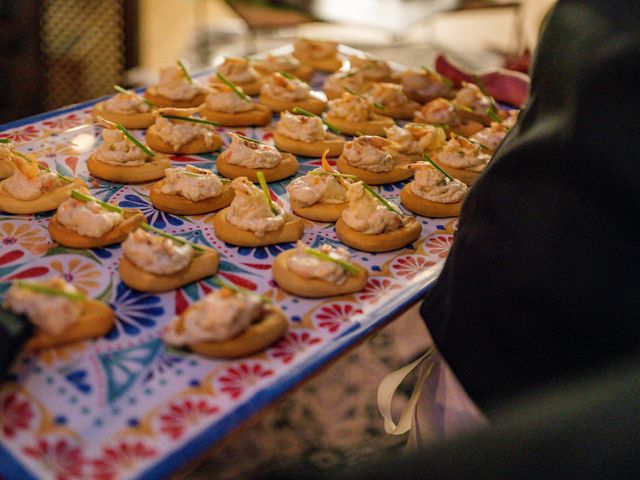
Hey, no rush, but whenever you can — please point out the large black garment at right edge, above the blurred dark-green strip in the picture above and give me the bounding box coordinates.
[421,0,640,407]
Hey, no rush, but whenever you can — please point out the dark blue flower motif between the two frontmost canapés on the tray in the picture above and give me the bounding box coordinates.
[106,283,164,340]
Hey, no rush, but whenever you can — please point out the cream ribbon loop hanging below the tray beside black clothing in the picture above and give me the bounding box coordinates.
[378,347,436,435]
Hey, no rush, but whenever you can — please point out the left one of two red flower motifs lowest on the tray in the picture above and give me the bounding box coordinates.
[23,438,85,480]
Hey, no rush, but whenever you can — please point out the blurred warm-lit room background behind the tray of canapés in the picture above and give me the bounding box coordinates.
[0,0,553,123]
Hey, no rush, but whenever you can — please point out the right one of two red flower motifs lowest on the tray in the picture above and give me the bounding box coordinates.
[91,441,157,480]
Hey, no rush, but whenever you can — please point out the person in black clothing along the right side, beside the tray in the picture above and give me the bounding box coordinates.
[264,0,640,480]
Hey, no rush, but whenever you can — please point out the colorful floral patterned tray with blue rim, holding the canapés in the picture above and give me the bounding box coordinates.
[0,47,453,480]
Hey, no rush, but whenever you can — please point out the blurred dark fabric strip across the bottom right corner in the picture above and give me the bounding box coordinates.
[266,357,640,480]
